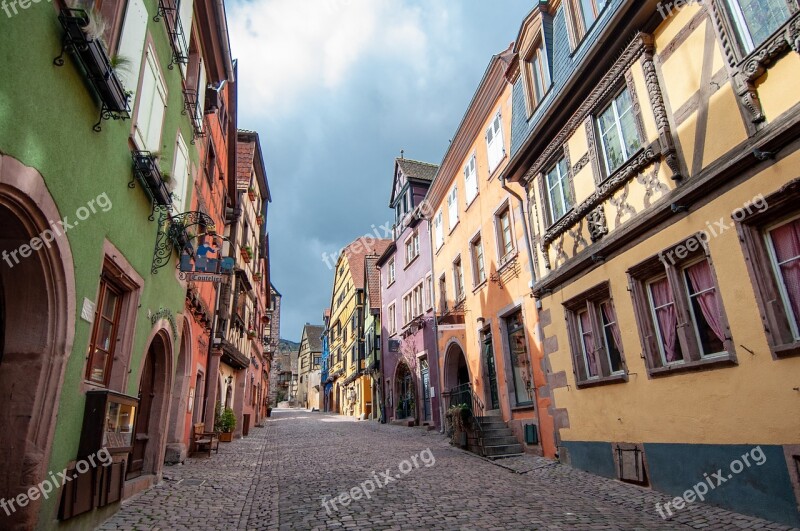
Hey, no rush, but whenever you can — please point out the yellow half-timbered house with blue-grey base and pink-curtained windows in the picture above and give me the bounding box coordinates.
[506,0,800,526]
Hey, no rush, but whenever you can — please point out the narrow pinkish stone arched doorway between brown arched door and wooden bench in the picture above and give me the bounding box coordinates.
[166,321,191,463]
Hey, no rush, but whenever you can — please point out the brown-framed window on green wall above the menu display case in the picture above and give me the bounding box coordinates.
[86,276,122,386]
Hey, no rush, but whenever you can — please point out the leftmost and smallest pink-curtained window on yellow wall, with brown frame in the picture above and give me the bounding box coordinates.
[564,283,626,385]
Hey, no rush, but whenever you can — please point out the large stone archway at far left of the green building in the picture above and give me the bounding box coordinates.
[0,155,75,530]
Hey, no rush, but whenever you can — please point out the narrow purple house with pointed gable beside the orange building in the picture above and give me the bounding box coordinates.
[377,157,442,429]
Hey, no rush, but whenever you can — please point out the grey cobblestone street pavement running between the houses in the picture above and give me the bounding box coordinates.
[100,410,788,530]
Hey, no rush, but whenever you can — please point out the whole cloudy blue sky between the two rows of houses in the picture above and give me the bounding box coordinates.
[227,0,533,341]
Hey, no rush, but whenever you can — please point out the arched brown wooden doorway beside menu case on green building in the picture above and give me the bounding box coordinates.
[127,331,172,479]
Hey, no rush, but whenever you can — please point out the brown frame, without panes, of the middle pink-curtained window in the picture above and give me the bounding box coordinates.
[627,239,738,377]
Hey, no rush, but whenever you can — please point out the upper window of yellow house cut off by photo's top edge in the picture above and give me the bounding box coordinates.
[725,0,791,53]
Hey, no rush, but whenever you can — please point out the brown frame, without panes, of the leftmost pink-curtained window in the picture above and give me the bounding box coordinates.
[563,282,628,389]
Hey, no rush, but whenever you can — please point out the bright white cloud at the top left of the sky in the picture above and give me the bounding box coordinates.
[228,0,438,116]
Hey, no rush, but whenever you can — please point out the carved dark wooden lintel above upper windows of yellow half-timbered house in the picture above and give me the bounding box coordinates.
[522,33,645,182]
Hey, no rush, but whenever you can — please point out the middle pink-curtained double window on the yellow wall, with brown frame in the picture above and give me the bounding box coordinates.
[628,236,734,373]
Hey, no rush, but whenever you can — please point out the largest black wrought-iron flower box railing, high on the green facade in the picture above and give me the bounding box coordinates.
[53,8,131,132]
